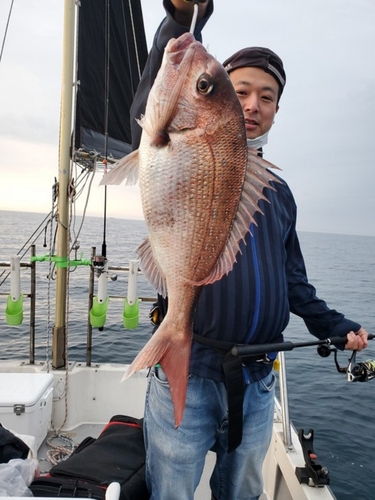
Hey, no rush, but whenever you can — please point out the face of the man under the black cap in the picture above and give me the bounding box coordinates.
[229,67,279,139]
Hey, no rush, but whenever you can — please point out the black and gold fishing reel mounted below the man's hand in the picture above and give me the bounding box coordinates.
[317,344,375,382]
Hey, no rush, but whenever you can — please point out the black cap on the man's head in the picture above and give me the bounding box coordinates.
[223,47,286,98]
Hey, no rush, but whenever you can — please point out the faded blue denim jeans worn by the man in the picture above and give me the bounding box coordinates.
[144,368,275,500]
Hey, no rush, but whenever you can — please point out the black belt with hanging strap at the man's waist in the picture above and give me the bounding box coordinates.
[193,334,267,453]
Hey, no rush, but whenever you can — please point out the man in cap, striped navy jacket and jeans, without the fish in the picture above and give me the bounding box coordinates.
[131,0,367,500]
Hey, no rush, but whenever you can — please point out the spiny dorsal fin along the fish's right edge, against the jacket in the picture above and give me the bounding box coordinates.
[194,148,280,285]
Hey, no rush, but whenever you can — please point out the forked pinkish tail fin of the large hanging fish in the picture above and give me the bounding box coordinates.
[123,320,191,427]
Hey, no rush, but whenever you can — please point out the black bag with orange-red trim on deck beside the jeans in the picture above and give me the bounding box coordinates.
[29,415,149,500]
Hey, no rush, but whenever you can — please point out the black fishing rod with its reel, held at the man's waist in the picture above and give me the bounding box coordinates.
[231,335,375,382]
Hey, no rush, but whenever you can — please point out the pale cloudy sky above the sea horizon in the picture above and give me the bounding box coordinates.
[0,0,375,236]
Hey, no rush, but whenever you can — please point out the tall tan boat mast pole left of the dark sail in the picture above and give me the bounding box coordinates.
[52,0,75,368]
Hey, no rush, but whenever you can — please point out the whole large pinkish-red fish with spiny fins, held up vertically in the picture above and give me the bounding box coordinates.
[102,33,277,426]
